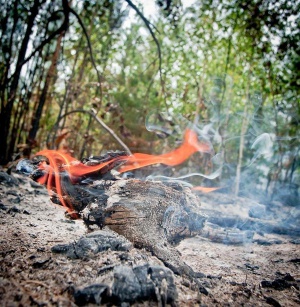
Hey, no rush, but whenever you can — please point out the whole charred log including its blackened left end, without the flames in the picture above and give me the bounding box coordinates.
[19,157,206,277]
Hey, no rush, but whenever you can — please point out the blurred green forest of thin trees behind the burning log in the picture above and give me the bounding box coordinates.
[0,0,300,205]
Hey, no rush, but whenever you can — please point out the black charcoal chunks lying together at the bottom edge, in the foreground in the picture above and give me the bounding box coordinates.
[73,264,178,306]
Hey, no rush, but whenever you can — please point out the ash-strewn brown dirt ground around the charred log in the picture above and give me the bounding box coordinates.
[0,175,300,306]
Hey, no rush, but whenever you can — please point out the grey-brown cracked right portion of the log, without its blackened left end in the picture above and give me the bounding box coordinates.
[81,179,205,275]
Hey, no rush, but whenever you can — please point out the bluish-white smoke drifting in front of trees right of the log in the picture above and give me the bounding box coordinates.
[139,76,300,242]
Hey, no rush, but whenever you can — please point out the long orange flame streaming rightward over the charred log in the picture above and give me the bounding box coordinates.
[36,129,212,214]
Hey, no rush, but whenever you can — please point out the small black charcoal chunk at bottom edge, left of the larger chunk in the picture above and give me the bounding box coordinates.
[73,284,108,306]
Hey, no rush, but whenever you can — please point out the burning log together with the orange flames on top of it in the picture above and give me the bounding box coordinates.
[17,129,213,278]
